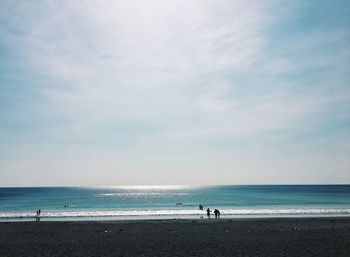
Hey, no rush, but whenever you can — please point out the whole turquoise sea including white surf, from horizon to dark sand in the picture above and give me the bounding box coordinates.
[0,185,350,221]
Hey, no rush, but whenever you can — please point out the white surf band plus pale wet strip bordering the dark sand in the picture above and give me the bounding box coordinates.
[0,206,350,222]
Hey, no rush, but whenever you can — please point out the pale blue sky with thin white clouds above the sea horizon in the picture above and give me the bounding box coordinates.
[0,0,350,186]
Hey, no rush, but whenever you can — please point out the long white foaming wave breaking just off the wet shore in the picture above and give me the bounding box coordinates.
[0,209,350,219]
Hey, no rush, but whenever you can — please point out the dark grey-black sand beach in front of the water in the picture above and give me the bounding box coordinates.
[0,218,350,257]
